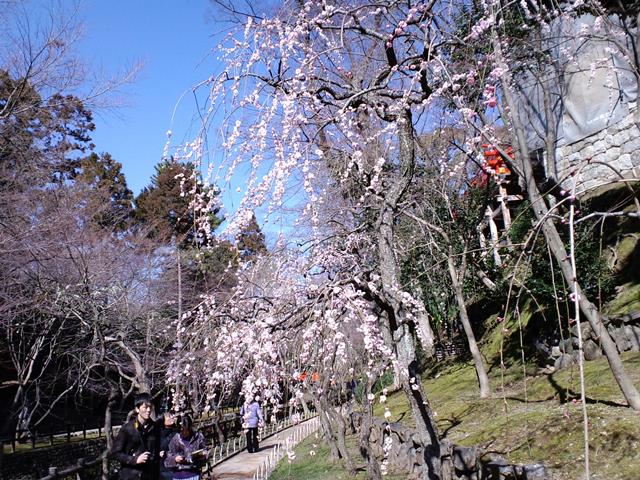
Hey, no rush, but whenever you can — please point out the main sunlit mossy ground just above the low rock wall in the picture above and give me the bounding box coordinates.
[375,353,640,480]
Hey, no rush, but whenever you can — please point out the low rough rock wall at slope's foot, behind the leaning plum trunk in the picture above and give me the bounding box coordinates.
[352,413,549,480]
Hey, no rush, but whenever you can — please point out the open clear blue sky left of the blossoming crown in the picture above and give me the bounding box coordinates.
[78,0,222,194]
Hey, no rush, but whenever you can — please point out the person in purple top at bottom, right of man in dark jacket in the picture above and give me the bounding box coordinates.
[165,415,208,480]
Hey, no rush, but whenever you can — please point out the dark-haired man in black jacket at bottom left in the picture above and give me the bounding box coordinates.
[111,393,160,480]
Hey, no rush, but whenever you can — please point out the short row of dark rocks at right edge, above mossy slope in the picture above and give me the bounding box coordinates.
[551,312,640,370]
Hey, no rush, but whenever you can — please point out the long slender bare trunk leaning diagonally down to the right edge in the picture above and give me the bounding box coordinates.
[493,30,640,410]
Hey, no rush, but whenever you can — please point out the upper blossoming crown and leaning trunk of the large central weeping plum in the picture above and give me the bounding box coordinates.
[175,1,476,478]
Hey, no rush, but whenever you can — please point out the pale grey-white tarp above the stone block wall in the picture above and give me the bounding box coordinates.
[517,14,638,149]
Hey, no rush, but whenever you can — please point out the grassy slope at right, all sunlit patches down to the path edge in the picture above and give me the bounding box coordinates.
[270,285,640,480]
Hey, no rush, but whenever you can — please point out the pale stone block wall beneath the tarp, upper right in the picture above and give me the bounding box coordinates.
[547,109,640,195]
